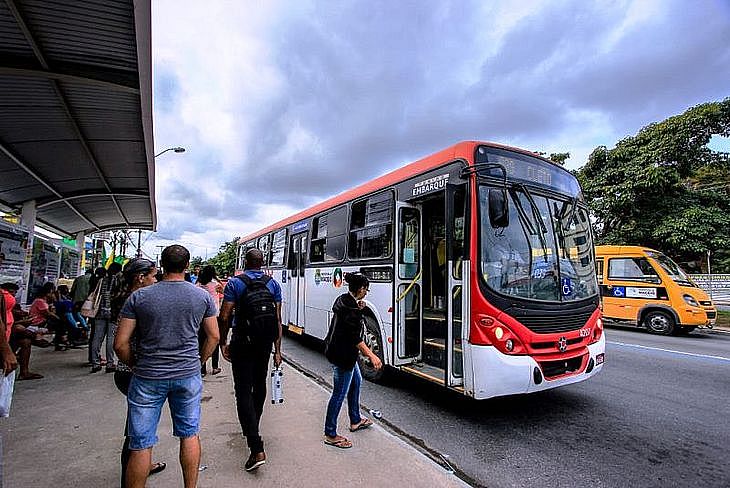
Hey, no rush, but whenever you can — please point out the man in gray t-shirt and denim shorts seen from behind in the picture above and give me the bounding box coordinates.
[114,245,219,488]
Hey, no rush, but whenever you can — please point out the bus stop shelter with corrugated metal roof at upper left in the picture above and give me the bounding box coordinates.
[0,0,156,302]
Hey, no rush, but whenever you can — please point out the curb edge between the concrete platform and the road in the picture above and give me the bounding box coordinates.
[281,354,478,488]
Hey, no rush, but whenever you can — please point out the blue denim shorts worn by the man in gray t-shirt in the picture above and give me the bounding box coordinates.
[127,374,203,451]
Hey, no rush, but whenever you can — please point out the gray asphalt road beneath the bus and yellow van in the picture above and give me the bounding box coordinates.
[284,329,730,488]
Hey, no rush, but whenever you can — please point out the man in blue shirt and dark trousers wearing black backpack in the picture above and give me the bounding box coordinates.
[218,249,281,471]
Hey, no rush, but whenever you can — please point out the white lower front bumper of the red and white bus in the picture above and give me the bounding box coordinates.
[471,334,606,400]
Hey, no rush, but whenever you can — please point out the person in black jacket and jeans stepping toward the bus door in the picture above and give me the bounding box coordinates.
[324,273,383,449]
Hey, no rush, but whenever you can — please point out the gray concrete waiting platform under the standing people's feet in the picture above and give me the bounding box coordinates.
[0,348,467,488]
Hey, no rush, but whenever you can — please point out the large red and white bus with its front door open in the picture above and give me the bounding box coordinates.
[237,141,605,399]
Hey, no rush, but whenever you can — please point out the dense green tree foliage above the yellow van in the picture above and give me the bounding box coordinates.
[576,98,730,271]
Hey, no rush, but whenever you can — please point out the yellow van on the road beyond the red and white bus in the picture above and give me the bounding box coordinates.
[596,246,717,335]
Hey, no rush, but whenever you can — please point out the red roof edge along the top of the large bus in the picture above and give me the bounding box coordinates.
[238,141,555,243]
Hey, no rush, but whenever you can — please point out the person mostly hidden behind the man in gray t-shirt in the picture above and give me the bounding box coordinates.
[112,258,167,488]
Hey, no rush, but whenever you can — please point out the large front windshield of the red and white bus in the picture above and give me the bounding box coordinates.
[479,185,598,302]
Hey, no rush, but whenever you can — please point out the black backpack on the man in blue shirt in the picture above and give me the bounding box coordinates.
[234,274,279,345]
